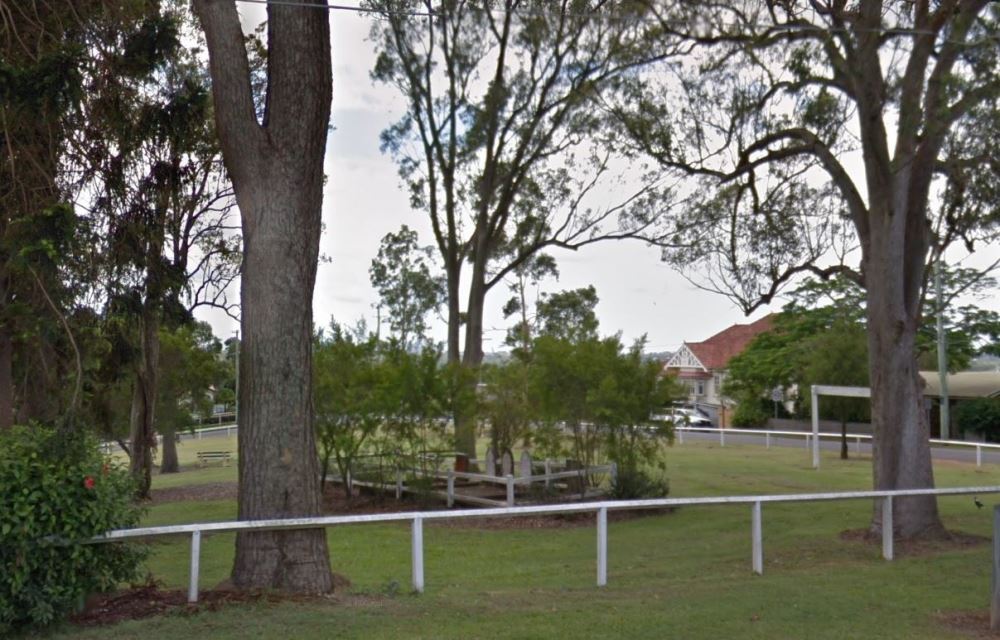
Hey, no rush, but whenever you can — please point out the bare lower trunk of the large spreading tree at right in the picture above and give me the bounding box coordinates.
[863,190,945,539]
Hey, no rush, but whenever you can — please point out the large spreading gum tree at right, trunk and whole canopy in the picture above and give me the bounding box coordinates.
[615,0,1000,538]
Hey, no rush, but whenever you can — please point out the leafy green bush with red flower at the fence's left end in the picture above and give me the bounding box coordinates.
[0,426,143,637]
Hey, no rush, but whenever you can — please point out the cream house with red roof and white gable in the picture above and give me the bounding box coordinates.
[663,315,772,426]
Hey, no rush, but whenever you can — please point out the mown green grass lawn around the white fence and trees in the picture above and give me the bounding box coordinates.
[48,441,1000,640]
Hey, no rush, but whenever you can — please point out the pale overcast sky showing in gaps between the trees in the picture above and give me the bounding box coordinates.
[200,3,1000,352]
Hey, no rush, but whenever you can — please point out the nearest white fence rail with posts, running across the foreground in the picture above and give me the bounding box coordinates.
[87,486,1000,602]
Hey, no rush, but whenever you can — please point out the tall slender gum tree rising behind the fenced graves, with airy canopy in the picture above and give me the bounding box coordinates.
[368,0,684,456]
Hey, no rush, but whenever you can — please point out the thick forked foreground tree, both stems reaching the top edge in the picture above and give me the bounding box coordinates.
[193,0,332,593]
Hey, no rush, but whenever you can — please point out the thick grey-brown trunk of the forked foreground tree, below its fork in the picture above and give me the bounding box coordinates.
[233,179,332,593]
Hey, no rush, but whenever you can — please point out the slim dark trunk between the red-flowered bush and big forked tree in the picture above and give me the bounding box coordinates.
[129,308,160,500]
